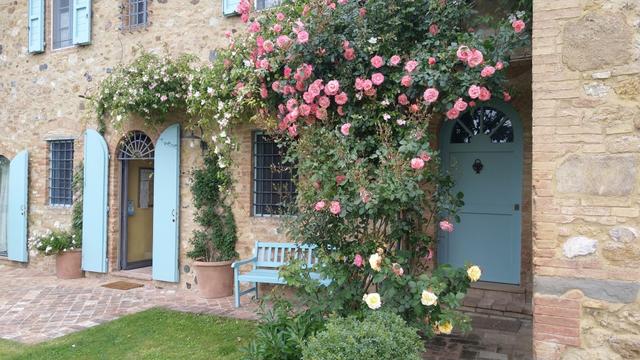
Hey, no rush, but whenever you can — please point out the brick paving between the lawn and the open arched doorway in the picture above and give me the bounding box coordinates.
[0,265,256,344]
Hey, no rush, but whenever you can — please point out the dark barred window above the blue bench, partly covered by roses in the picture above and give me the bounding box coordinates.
[252,132,296,216]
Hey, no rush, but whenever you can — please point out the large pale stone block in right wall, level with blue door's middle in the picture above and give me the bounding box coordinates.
[556,155,638,196]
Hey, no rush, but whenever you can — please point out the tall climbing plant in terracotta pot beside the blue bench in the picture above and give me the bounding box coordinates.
[187,154,238,299]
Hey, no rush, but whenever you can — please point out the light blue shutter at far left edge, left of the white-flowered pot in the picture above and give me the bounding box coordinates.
[7,150,29,262]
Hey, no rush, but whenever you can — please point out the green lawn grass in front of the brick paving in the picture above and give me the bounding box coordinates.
[0,309,255,360]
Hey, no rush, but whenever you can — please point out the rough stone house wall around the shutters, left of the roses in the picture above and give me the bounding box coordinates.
[0,0,288,288]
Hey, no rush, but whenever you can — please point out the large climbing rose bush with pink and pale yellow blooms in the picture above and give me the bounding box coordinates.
[188,0,528,344]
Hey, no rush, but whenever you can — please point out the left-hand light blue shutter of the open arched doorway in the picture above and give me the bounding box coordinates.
[82,129,109,273]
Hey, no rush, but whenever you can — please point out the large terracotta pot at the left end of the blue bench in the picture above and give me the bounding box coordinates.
[193,261,233,299]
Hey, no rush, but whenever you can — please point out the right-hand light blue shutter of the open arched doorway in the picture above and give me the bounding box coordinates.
[153,124,180,282]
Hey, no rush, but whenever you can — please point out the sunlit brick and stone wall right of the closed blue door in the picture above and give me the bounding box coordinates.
[533,0,640,359]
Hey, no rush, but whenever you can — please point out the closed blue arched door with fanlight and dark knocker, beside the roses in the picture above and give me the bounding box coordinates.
[438,103,522,284]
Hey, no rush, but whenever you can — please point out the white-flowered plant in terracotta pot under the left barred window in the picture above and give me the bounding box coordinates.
[34,225,83,279]
